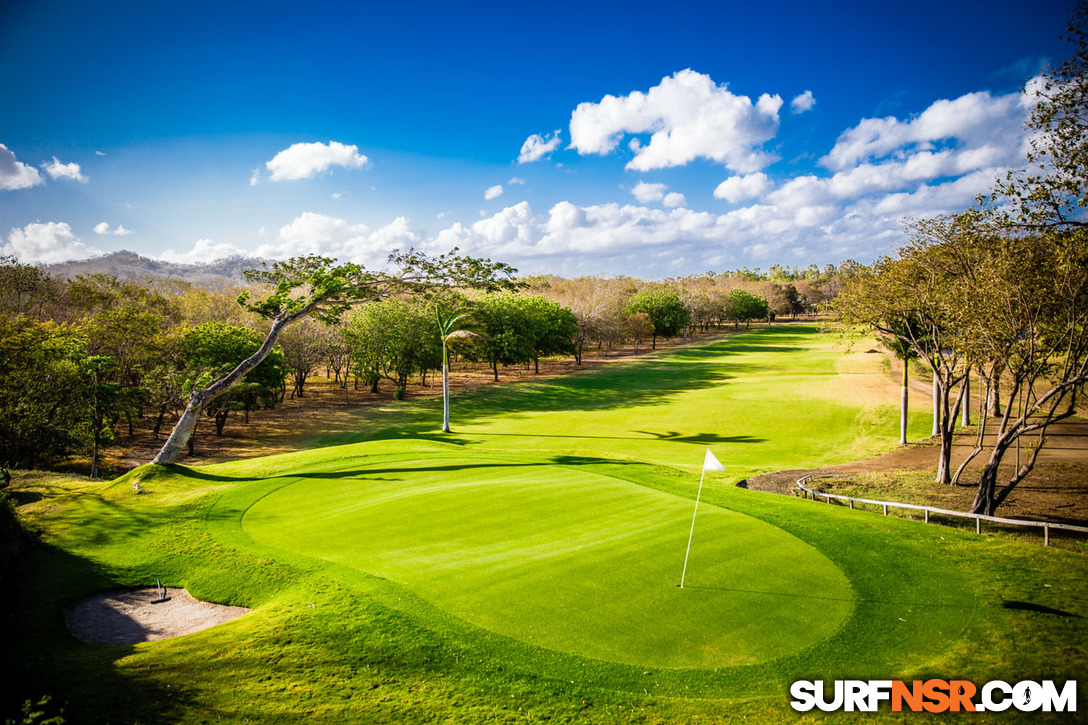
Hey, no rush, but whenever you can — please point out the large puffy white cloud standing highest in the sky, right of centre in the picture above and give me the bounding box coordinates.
[570,69,782,173]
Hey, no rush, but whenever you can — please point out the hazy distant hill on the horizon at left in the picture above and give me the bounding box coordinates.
[42,251,269,284]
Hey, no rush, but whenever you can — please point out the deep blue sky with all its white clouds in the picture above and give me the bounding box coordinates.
[0,0,1074,279]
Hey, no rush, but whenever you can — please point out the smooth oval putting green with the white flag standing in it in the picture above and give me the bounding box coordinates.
[242,454,854,667]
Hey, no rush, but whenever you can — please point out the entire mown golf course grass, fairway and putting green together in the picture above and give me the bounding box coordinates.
[3,328,1088,723]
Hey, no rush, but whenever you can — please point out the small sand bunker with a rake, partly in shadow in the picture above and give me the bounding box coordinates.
[64,587,249,644]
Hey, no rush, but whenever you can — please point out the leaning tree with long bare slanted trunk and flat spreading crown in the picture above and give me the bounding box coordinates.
[153,249,514,464]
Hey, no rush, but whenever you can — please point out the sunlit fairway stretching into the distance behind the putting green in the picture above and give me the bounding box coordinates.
[317,325,930,480]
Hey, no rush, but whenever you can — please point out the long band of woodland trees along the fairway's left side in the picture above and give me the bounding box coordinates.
[0,253,854,476]
